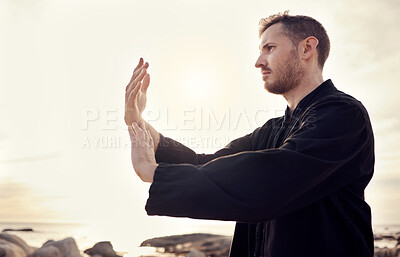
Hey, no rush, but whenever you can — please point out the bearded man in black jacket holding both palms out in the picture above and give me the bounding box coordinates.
[125,13,374,257]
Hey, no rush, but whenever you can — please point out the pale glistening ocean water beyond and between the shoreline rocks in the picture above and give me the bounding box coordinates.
[0,222,400,257]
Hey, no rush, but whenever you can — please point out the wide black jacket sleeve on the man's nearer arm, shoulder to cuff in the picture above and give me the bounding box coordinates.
[146,101,373,222]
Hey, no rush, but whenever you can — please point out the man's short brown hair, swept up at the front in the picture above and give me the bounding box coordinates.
[259,11,330,68]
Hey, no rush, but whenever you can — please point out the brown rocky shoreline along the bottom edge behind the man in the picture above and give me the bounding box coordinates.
[0,230,400,257]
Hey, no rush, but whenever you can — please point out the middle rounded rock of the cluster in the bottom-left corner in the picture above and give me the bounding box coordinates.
[28,237,82,257]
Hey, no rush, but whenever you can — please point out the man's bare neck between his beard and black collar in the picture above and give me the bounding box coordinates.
[283,73,324,113]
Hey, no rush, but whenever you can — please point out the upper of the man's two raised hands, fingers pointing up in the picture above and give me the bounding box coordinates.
[124,58,150,126]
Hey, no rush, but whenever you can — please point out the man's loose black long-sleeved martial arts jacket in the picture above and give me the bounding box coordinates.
[146,80,374,257]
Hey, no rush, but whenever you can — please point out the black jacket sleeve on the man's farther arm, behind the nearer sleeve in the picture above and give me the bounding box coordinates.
[155,130,253,165]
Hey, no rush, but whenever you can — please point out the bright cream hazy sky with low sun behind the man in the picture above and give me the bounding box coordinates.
[0,0,400,242]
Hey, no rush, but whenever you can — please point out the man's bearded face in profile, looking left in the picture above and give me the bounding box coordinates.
[255,23,304,94]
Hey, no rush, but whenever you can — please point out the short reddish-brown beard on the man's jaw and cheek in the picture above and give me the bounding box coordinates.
[264,50,304,95]
